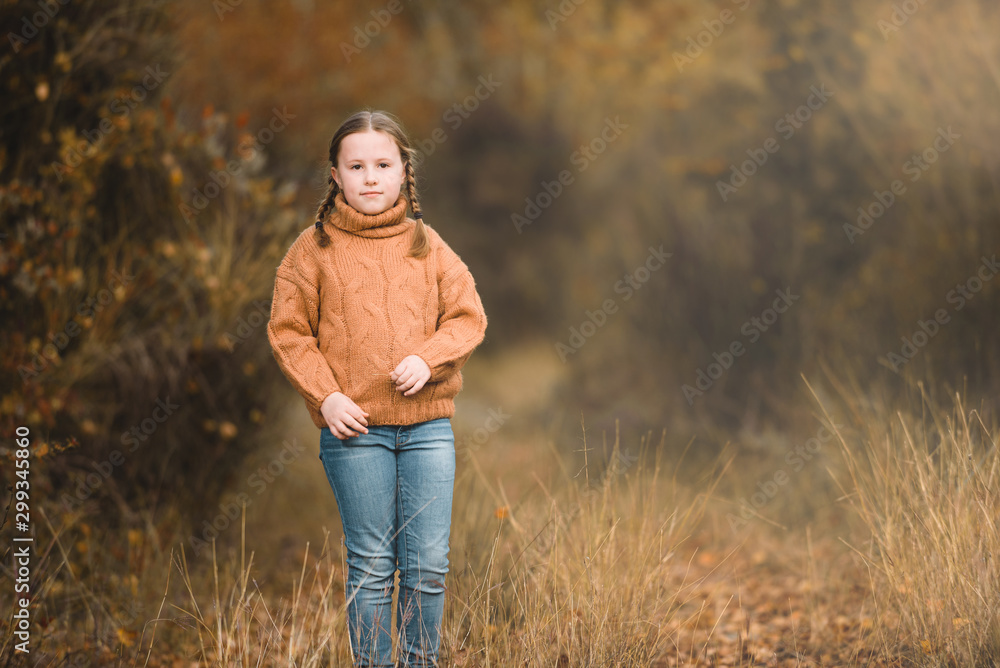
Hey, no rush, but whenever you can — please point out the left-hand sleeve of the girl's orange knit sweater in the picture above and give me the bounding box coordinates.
[267,240,341,412]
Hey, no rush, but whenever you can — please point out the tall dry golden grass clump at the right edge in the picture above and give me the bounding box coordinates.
[810,374,1000,666]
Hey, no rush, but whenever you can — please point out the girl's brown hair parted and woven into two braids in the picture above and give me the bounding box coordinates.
[316,109,431,257]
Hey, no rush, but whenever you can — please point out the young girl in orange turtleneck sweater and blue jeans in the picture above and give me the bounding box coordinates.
[268,111,486,666]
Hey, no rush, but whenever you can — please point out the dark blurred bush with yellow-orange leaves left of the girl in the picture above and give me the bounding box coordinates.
[0,0,300,525]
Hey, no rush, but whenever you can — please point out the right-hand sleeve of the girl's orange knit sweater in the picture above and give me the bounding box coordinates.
[414,237,486,383]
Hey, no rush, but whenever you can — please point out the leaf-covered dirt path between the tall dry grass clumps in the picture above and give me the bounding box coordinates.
[654,534,901,666]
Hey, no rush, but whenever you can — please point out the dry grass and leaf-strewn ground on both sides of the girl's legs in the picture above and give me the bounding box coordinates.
[7,370,1000,666]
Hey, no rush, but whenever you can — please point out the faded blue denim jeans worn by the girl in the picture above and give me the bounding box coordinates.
[319,418,455,666]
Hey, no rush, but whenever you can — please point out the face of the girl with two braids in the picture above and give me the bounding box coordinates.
[330,130,403,215]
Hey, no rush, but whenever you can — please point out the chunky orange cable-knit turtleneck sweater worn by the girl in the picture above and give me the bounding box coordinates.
[267,192,486,429]
